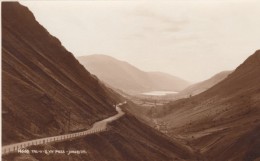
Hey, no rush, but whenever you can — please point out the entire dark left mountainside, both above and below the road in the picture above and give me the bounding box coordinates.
[2,2,200,161]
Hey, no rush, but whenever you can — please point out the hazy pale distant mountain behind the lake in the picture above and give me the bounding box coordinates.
[78,55,189,93]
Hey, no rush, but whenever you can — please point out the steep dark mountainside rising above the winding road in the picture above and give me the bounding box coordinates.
[2,2,116,144]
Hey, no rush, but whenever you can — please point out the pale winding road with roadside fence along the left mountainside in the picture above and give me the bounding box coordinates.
[2,101,127,155]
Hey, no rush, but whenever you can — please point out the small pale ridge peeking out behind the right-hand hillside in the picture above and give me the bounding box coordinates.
[174,71,232,99]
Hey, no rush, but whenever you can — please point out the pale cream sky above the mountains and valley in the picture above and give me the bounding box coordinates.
[20,0,260,83]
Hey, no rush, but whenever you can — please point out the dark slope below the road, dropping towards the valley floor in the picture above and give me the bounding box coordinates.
[3,112,202,161]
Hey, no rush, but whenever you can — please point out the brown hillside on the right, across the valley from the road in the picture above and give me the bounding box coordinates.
[155,50,260,161]
